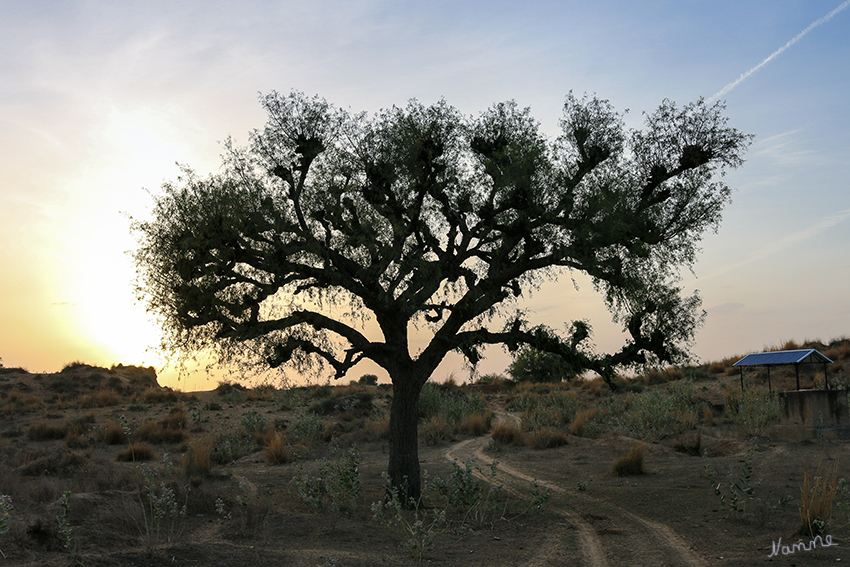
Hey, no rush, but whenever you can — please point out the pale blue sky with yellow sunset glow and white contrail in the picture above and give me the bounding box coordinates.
[0,0,850,389]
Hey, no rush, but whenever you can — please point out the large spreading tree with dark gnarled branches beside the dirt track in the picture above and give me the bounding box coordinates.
[134,92,750,504]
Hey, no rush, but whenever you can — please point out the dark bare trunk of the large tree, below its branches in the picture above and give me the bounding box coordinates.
[387,375,424,508]
